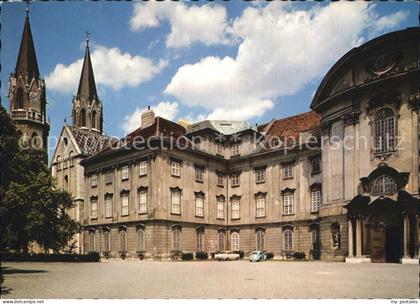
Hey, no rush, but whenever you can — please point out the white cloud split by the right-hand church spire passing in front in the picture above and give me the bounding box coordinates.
[45,46,167,93]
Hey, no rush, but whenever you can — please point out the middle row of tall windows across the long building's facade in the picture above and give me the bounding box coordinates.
[90,187,321,219]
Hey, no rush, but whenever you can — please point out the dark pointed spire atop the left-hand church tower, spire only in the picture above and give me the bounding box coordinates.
[15,7,39,77]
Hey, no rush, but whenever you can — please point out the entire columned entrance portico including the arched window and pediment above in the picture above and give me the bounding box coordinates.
[344,164,420,264]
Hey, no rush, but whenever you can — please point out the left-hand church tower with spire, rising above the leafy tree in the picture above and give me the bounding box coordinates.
[9,8,50,151]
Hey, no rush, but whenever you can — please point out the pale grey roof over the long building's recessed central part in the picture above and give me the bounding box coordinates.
[187,120,255,135]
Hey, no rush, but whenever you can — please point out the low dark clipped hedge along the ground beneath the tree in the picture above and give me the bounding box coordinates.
[1,252,101,262]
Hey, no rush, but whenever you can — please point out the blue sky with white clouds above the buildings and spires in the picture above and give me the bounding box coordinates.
[1,1,418,154]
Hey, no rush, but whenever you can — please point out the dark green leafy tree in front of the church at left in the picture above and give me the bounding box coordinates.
[0,105,80,252]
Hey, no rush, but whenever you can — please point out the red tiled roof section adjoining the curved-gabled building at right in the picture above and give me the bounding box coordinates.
[266,111,321,138]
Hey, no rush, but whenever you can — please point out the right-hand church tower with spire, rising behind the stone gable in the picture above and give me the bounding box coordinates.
[72,38,103,134]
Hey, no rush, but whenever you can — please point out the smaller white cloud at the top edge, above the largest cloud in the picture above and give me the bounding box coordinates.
[130,1,229,48]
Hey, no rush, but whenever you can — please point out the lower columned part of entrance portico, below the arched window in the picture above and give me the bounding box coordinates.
[345,191,419,264]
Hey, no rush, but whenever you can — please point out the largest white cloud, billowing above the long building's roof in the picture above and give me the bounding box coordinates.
[165,1,410,119]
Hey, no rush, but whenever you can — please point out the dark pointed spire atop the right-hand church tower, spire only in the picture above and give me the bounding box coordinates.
[77,32,97,100]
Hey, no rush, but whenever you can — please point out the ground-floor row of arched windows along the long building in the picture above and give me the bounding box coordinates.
[89,223,341,253]
